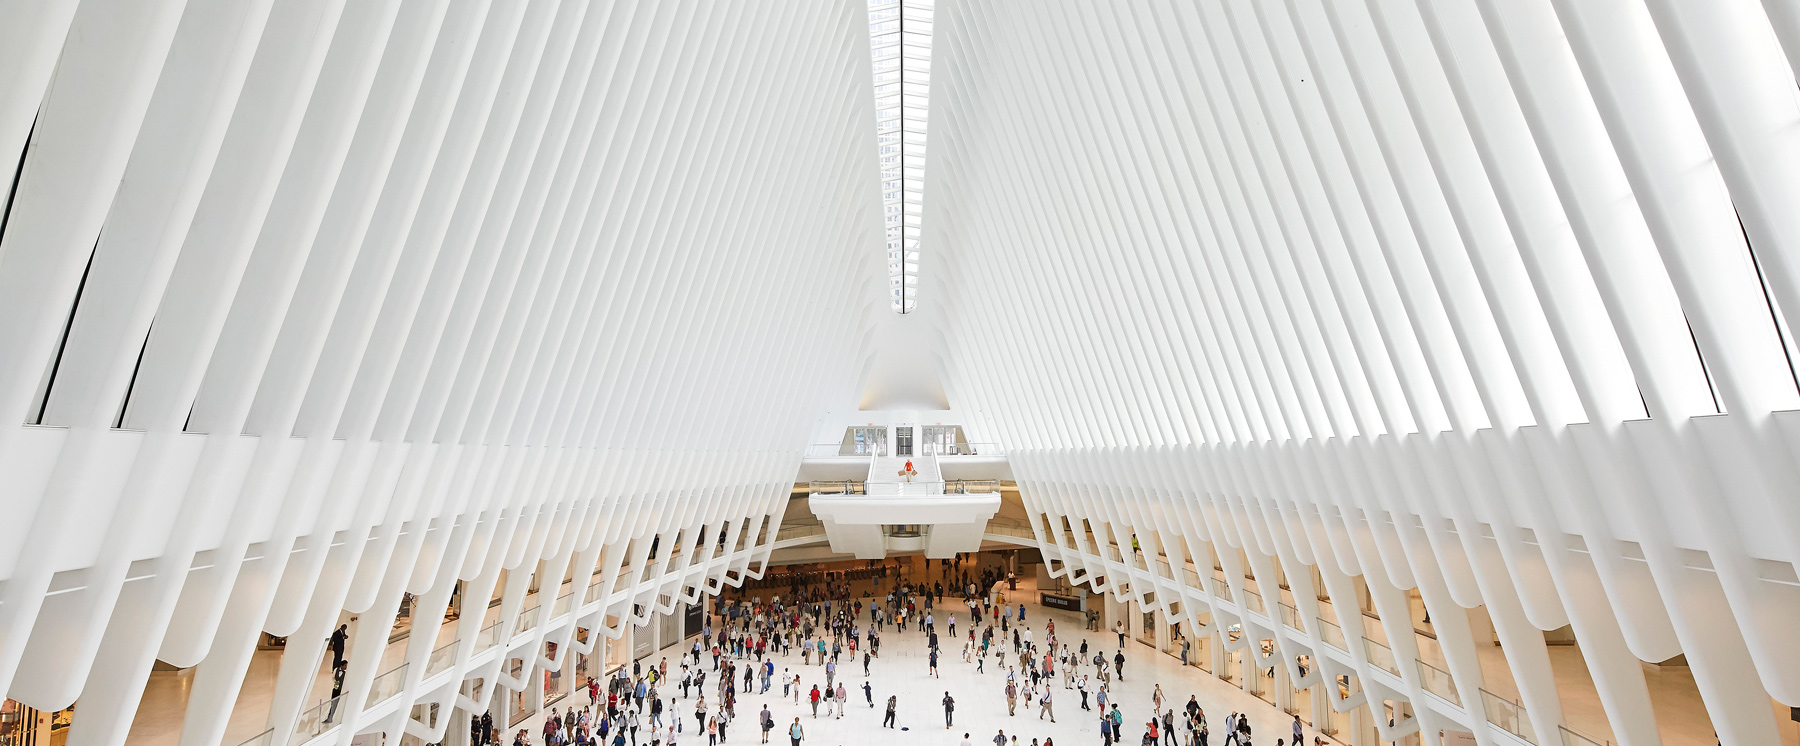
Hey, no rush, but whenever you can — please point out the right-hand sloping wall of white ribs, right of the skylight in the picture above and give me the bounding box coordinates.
[922,0,1800,746]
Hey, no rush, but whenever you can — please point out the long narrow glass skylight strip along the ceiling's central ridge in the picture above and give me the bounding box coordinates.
[869,0,934,314]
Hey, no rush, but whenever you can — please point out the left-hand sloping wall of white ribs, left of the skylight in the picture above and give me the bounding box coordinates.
[0,0,886,746]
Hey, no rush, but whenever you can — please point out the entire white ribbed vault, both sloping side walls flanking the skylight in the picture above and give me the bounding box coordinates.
[0,0,1800,746]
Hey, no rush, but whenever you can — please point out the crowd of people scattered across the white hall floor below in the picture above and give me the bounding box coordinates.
[472,557,1323,746]
